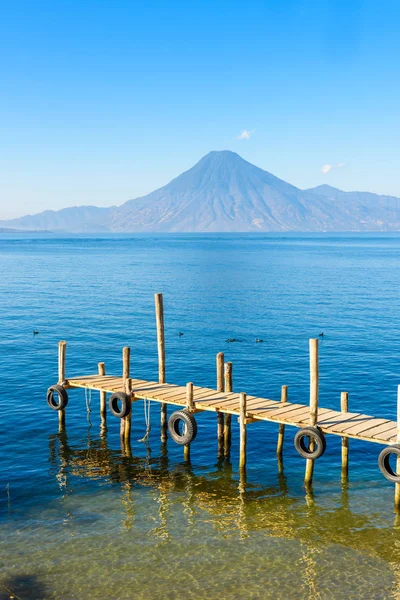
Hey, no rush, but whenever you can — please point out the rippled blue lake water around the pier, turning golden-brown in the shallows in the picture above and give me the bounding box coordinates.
[0,235,400,600]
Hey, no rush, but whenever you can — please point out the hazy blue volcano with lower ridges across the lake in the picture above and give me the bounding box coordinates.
[0,151,400,232]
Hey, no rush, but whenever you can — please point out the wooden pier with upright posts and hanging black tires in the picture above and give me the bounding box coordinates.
[47,294,400,511]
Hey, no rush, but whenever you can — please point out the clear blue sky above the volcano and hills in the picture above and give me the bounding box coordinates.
[0,0,400,218]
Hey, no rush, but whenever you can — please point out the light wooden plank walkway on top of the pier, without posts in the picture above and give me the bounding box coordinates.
[66,375,397,445]
